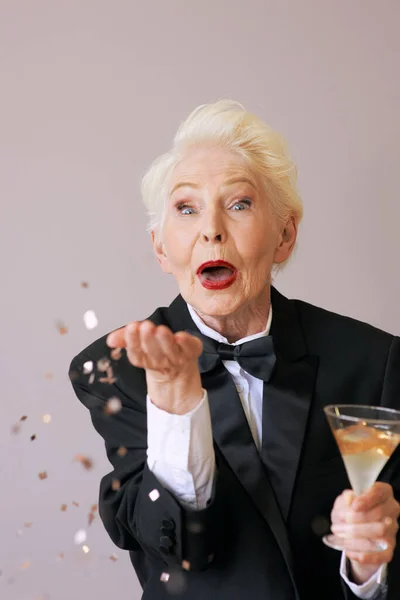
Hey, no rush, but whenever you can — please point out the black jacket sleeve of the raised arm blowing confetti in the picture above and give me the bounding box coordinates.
[69,353,220,571]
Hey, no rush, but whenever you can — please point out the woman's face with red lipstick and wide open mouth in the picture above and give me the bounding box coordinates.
[153,147,294,317]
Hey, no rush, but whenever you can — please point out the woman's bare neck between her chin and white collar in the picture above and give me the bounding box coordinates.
[197,289,271,343]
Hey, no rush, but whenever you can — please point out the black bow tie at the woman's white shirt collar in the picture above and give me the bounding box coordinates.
[186,330,276,381]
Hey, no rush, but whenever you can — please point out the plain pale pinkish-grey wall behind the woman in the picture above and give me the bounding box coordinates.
[0,0,400,600]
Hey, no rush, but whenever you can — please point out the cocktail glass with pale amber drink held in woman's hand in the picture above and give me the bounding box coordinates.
[322,404,400,551]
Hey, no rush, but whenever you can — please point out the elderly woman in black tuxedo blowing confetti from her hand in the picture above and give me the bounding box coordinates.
[70,101,400,600]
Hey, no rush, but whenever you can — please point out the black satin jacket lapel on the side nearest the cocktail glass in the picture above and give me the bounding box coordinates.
[261,288,318,520]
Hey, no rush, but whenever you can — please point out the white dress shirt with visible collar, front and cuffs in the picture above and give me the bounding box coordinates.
[147,305,386,600]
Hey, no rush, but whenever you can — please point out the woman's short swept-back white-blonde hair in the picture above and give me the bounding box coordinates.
[141,100,303,237]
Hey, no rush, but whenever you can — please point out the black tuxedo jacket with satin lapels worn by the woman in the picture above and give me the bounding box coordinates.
[69,288,400,600]
